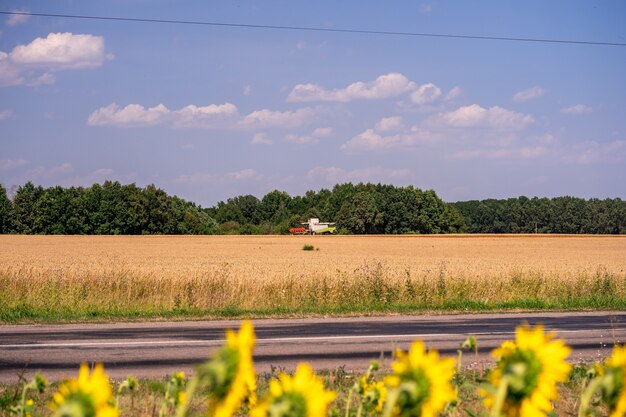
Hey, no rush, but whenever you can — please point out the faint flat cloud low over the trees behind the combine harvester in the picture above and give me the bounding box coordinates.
[306,166,411,184]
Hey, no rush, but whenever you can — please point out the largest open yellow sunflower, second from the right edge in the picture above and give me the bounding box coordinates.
[481,325,571,417]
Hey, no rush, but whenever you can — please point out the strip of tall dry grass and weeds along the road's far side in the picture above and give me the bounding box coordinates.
[0,262,626,322]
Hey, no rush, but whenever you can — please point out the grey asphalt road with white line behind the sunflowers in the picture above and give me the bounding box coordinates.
[0,312,626,383]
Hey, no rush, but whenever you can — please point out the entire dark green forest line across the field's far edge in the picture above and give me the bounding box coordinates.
[0,181,626,235]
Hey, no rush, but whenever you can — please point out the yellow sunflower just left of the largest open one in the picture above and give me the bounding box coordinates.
[385,340,456,417]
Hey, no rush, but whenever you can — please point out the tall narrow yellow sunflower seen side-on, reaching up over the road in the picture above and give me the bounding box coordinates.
[205,321,256,417]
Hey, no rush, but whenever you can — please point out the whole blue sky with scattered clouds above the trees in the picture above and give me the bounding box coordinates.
[0,0,626,206]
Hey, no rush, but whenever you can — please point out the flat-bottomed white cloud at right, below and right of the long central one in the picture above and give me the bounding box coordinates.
[431,104,534,129]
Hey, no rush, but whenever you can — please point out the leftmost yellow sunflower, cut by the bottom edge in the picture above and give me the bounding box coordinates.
[50,363,119,417]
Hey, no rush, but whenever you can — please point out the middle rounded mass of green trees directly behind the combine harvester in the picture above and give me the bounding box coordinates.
[207,183,465,234]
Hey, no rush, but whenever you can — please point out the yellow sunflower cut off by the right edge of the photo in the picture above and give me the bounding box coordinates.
[600,346,626,417]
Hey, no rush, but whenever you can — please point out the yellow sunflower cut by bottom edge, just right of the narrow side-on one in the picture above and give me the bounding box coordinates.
[250,363,336,417]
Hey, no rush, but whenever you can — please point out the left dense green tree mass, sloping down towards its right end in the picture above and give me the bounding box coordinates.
[0,181,219,235]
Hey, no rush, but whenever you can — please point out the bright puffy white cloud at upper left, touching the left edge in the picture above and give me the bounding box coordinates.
[0,32,111,86]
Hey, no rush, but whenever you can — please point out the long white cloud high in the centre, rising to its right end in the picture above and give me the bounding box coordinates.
[287,72,416,103]
